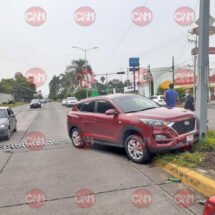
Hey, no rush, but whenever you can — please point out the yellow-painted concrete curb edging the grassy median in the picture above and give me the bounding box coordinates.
[155,161,215,197]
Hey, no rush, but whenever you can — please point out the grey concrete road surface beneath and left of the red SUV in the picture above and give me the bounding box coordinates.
[0,102,212,215]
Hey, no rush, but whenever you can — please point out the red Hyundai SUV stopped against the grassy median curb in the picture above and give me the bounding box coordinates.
[67,94,198,163]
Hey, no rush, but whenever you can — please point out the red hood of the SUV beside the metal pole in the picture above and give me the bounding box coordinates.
[126,107,195,122]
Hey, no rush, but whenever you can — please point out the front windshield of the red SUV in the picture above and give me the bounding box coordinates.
[113,95,159,113]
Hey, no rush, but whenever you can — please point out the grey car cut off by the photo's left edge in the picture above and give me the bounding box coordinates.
[0,107,17,140]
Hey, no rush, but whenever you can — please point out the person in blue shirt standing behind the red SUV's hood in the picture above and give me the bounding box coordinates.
[164,84,179,108]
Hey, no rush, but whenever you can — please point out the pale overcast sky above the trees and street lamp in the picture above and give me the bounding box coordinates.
[0,0,215,94]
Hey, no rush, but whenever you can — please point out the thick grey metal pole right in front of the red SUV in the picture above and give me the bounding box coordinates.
[196,0,210,140]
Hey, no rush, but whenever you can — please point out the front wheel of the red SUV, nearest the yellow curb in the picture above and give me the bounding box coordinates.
[125,134,151,163]
